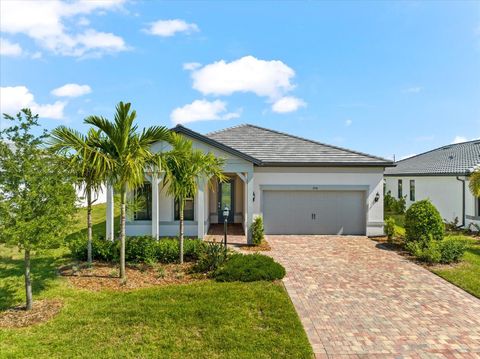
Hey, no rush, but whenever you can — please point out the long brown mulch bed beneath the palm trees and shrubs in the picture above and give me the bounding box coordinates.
[59,262,206,291]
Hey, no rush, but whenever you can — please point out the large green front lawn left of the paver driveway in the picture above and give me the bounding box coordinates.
[0,205,312,358]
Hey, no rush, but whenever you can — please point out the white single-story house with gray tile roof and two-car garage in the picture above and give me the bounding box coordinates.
[107,124,393,245]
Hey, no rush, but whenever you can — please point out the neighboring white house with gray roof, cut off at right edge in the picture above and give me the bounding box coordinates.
[385,140,480,231]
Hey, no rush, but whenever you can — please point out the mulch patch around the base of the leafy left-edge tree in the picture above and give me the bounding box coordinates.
[0,299,63,328]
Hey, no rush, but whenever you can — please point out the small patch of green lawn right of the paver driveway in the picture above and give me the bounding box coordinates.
[389,215,480,298]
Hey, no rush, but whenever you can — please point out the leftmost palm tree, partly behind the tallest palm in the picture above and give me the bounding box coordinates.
[49,126,107,265]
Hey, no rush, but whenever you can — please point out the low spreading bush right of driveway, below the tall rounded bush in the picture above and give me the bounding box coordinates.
[406,238,467,264]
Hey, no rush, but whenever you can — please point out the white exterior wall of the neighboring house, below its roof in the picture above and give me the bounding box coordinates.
[385,176,480,231]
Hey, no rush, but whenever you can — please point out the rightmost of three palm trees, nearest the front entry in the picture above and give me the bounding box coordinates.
[162,133,226,263]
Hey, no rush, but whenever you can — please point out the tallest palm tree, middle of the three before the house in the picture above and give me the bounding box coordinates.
[85,102,170,281]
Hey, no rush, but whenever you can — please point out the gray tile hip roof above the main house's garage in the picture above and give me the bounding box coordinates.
[205,124,392,166]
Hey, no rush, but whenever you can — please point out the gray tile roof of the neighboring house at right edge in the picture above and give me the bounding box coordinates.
[385,139,480,176]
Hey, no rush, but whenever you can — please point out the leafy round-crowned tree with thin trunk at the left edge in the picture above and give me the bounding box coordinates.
[0,109,76,310]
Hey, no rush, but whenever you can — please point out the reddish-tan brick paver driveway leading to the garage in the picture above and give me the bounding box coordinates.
[267,236,480,358]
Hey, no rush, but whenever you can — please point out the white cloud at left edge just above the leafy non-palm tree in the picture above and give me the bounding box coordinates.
[0,86,67,120]
